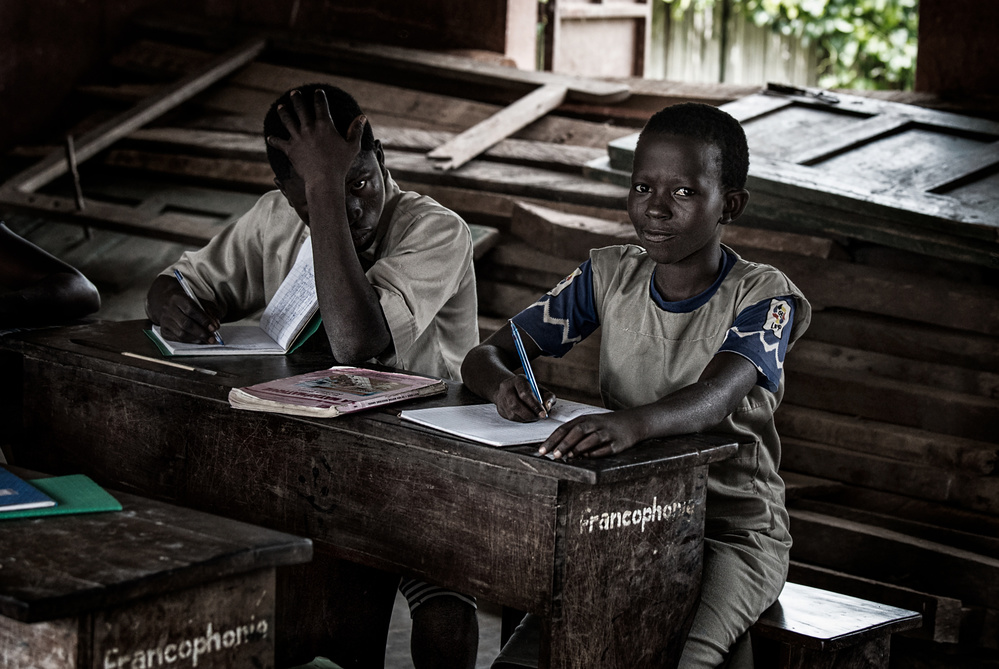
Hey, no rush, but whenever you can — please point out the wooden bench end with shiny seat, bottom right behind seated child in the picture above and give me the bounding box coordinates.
[750,583,922,669]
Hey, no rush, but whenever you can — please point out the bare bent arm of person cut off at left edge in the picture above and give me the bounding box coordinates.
[0,221,101,330]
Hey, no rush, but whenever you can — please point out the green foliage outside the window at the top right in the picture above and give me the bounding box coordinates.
[664,0,918,90]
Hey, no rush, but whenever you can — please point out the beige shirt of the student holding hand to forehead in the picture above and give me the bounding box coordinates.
[163,170,479,380]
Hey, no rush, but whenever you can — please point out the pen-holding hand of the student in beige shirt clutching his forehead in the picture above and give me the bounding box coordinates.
[146,274,221,344]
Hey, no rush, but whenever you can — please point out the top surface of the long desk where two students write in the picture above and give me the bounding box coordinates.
[0,321,736,484]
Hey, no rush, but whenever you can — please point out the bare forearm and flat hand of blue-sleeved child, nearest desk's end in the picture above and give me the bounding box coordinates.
[539,352,757,458]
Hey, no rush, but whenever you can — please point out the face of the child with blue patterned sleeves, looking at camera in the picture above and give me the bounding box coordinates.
[628,134,748,265]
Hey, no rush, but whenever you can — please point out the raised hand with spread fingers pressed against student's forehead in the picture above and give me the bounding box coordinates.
[267,90,367,184]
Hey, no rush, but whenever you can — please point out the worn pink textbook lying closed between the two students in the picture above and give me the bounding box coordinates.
[229,366,447,418]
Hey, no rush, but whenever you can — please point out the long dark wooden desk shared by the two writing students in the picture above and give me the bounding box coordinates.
[0,321,736,669]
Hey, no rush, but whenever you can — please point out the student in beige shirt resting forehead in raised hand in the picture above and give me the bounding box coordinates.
[146,84,478,669]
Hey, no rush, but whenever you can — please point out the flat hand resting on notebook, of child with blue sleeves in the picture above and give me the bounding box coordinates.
[538,411,642,458]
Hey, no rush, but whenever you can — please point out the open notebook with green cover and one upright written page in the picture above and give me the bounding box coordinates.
[146,239,320,356]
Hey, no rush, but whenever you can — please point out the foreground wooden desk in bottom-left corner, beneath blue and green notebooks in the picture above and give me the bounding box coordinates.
[0,472,312,669]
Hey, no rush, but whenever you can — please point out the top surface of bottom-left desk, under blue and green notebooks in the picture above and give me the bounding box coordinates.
[0,469,312,622]
